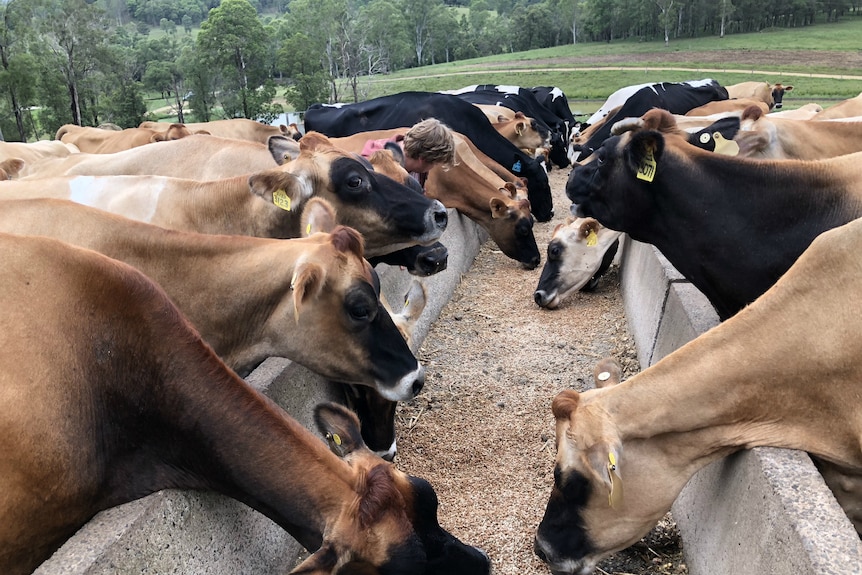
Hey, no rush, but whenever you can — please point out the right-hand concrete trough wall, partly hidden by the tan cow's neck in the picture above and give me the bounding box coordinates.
[621,240,862,575]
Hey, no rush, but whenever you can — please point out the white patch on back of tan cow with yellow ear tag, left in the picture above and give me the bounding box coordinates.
[69,176,165,222]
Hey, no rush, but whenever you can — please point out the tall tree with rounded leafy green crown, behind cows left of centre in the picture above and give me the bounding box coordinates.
[197,0,270,119]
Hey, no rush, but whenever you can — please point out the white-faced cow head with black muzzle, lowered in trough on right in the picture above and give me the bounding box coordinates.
[533,218,622,309]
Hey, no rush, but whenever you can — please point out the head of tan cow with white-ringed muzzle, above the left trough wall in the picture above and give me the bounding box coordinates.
[280,223,425,401]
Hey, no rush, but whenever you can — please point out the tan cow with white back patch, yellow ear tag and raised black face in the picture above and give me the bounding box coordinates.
[5,135,448,257]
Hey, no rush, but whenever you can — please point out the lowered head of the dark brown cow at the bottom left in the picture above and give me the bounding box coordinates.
[298,404,491,575]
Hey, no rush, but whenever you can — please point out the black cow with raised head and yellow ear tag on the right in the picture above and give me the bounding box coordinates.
[566,111,862,319]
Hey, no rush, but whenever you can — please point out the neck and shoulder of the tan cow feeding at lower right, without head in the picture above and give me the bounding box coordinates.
[587,230,862,468]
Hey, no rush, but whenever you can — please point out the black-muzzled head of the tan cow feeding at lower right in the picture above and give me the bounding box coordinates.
[534,362,690,575]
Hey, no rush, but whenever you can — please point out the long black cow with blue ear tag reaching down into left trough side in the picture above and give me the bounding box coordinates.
[305,92,554,222]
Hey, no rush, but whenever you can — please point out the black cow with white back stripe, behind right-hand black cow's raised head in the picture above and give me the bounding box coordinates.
[572,78,727,159]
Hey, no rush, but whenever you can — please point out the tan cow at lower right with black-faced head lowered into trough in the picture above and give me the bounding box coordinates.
[535,220,862,575]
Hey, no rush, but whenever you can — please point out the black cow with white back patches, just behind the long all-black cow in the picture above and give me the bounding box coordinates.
[444,84,570,168]
